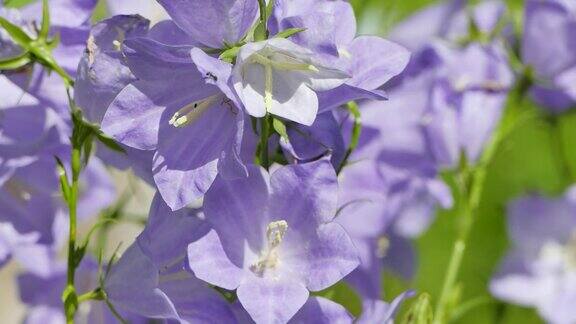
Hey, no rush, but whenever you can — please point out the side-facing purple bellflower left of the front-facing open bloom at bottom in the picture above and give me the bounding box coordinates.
[104,195,234,323]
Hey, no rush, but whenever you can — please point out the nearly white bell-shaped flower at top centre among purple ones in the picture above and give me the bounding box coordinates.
[232,38,348,126]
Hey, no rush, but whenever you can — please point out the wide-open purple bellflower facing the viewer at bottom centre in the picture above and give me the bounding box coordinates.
[188,159,358,323]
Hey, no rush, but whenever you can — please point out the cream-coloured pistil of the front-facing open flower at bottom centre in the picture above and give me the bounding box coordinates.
[250,220,288,276]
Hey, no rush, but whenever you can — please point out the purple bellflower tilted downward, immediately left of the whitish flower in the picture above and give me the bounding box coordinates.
[102,33,251,210]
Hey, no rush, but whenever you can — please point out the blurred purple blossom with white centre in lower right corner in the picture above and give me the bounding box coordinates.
[490,187,576,324]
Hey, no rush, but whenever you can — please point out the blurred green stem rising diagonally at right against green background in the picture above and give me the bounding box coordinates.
[433,74,530,324]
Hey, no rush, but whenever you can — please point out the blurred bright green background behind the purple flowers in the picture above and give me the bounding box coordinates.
[7,0,576,324]
